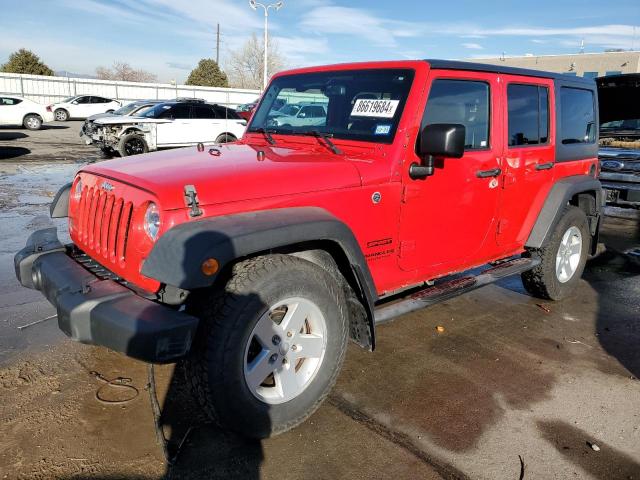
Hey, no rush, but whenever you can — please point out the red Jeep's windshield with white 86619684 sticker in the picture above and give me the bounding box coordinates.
[248,69,414,143]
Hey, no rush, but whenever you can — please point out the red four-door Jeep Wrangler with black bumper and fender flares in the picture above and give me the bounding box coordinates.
[15,60,602,437]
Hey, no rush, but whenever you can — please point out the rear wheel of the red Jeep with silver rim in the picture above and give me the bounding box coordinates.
[522,206,591,300]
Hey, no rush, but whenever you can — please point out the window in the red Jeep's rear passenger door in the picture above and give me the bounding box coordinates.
[507,84,549,147]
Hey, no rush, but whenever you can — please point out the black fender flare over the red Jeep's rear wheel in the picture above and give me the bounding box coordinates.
[525,175,603,248]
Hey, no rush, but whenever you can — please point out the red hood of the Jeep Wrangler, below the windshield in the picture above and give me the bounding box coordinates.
[82,143,361,210]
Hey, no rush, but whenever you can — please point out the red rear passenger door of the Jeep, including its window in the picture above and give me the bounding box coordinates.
[496,75,555,247]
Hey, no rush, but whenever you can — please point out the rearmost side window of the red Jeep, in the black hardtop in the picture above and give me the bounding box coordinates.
[560,87,596,145]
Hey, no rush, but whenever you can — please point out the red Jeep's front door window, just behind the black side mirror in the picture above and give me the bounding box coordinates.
[422,79,489,149]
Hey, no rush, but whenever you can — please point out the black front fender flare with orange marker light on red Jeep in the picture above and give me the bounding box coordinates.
[141,207,378,347]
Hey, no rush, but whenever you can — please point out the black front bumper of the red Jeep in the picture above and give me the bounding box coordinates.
[14,228,198,363]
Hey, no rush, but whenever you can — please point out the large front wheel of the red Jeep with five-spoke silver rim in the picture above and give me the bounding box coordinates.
[186,255,348,438]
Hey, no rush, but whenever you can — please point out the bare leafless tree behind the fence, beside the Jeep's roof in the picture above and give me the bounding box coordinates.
[225,33,286,89]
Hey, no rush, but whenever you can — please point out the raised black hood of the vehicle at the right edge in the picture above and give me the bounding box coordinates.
[596,73,640,123]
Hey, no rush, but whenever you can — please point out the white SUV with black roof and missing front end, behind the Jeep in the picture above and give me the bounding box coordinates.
[90,99,247,157]
